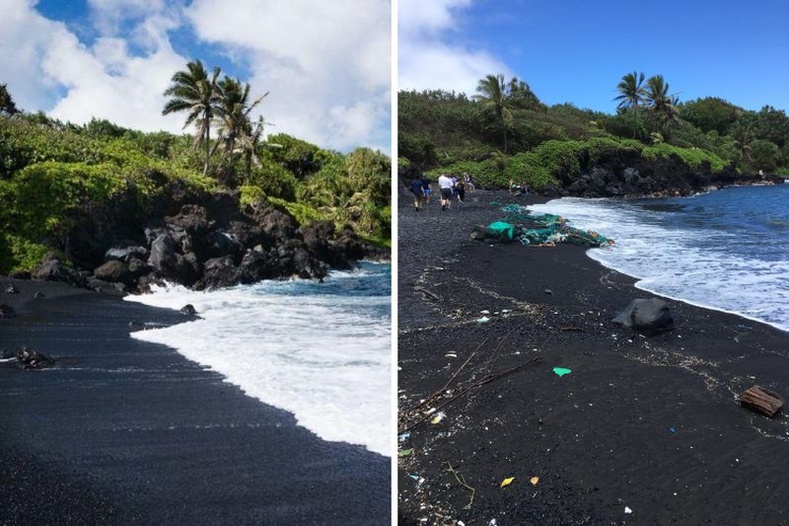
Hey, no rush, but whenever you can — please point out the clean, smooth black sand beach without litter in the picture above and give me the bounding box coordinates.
[0,278,391,525]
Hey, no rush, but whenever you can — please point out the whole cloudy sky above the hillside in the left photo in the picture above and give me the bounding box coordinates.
[0,0,392,153]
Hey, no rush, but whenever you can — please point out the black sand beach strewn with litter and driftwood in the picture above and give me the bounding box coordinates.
[398,191,789,526]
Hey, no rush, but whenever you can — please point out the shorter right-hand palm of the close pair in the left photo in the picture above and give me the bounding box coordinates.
[214,76,268,177]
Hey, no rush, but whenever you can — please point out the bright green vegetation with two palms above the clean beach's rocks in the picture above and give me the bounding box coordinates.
[0,61,391,274]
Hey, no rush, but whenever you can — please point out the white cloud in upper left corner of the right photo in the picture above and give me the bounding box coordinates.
[398,0,511,95]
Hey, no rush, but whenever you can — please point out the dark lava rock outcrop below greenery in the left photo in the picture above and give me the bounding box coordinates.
[16,185,388,291]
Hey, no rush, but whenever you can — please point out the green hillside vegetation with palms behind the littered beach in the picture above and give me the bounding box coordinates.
[398,71,789,189]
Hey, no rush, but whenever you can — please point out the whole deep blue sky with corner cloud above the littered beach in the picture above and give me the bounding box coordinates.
[398,0,789,113]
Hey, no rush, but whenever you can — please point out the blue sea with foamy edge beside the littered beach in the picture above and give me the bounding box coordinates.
[529,184,789,331]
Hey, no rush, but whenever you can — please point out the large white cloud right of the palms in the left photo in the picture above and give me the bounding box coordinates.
[187,0,391,151]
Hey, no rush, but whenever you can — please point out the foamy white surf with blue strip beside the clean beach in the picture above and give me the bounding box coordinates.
[128,262,394,456]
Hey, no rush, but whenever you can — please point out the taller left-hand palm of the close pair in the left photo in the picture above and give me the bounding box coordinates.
[162,60,220,175]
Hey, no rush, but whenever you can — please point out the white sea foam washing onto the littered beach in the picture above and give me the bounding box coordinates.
[529,198,789,331]
